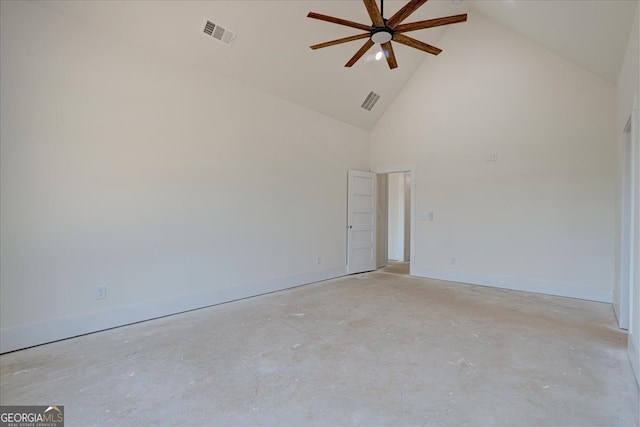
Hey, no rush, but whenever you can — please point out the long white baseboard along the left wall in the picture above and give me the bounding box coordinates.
[0,266,347,353]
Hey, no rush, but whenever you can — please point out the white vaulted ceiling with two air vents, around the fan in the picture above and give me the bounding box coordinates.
[36,0,638,130]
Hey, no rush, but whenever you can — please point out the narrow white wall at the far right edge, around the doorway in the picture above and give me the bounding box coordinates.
[615,0,640,384]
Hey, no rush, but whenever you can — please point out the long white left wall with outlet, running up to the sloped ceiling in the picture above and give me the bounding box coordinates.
[0,2,369,352]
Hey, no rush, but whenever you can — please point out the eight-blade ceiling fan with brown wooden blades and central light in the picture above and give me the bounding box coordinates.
[307,0,467,69]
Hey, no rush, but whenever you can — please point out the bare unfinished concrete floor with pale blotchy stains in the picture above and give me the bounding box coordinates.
[0,270,639,426]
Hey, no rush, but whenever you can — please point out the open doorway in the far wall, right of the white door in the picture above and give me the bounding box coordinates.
[376,171,413,275]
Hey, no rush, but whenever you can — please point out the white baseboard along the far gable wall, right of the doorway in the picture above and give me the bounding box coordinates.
[411,267,613,303]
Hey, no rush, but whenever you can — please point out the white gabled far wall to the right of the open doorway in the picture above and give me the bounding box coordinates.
[370,13,616,302]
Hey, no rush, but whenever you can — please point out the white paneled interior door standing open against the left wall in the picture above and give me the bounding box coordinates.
[347,170,377,274]
